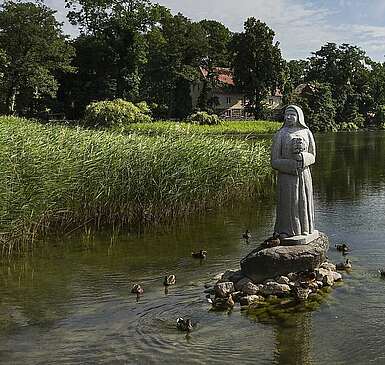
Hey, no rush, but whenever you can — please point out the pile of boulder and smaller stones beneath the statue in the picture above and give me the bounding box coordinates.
[206,234,342,309]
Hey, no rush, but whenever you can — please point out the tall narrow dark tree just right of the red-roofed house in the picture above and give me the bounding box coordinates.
[231,18,284,118]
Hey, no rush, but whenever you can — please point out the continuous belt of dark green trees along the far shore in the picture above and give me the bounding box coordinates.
[0,0,385,130]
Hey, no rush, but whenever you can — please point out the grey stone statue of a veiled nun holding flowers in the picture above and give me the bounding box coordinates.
[271,105,318,244]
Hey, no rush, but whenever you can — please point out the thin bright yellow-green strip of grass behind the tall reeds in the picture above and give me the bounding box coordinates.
[115,120,282,135]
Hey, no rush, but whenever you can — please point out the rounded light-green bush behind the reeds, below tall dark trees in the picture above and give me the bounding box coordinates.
[84,99,152,128]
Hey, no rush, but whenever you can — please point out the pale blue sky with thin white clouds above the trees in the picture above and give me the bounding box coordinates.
[45,0,385,61]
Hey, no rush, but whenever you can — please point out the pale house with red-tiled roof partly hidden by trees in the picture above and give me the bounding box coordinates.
[190,67,282,119]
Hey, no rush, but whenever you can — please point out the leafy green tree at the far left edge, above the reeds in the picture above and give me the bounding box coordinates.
[0,1,74,115]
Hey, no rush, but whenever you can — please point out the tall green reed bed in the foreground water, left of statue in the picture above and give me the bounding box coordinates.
[0,117,271,253]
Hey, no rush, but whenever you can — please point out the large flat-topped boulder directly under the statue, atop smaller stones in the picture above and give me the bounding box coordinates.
[241,234,329,283]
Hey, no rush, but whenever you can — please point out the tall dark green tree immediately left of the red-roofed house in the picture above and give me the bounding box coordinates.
[142,14,208,118]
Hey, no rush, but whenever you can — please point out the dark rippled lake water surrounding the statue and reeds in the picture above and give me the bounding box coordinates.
[0,132,385,365]
